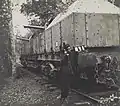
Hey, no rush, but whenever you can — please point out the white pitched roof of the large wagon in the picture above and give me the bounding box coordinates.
[46,0,120,29]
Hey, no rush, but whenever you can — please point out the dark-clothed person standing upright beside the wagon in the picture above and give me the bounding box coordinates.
[60,44,71,105]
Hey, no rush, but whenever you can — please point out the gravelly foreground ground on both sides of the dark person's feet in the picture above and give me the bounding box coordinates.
[0,69,119,106]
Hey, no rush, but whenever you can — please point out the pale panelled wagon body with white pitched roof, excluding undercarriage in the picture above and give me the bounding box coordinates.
[22,0,120,54]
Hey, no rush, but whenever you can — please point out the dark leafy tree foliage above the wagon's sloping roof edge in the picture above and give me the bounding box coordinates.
[21,0,59,25]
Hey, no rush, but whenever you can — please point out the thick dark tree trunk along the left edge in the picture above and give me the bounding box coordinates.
[0,0,12,76]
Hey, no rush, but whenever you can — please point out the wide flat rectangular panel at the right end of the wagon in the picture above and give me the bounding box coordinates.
[86,14,119,47]
